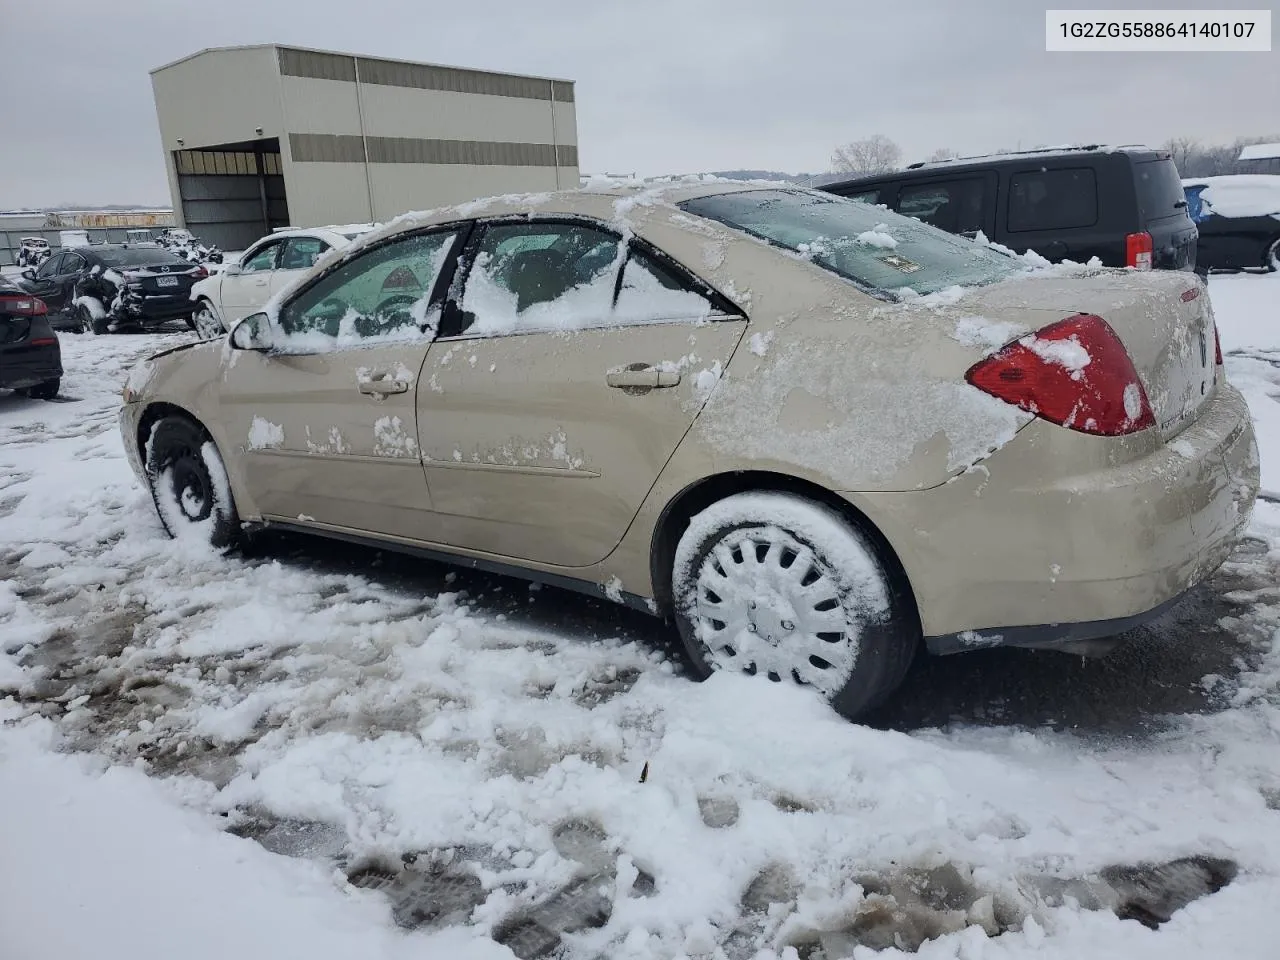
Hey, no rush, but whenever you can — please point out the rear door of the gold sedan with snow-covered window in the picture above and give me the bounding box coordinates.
[417,220,746,567]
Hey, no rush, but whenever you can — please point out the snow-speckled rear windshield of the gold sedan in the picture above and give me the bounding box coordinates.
[680,189,1020,296]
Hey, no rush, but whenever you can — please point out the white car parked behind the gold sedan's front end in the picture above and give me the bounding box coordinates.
[191,224,374,339]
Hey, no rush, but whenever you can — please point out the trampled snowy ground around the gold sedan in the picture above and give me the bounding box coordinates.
[0,275,1280,960]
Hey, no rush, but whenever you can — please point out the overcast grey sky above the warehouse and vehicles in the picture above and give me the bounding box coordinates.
[0,0,1280,207]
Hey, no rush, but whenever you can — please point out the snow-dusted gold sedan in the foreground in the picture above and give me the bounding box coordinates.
[120,180,1258,717]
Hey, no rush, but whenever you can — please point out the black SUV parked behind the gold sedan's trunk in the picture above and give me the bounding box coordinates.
[822,146,1197,270]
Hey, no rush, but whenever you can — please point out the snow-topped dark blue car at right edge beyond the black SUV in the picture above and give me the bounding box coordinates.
[1183,173,1280,273]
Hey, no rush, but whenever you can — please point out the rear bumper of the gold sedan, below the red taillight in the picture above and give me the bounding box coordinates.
[850,383,1258,653]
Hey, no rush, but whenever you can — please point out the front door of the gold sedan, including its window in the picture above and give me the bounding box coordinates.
[219,230,456,540]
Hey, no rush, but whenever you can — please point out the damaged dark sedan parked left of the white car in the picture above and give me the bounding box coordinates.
[20,243,207,333]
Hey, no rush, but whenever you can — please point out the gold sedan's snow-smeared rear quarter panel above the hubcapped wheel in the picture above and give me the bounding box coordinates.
[627,209,1029,490]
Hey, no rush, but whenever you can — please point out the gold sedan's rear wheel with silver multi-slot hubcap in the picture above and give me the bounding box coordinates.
[672,493,920,719]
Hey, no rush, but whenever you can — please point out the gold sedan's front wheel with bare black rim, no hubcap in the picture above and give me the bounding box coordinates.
[147,415,241,549]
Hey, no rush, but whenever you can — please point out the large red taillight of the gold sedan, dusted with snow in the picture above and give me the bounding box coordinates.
[965,314,1156,436]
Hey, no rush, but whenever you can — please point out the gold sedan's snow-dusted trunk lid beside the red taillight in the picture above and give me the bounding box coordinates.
[964,270,1217,440]
